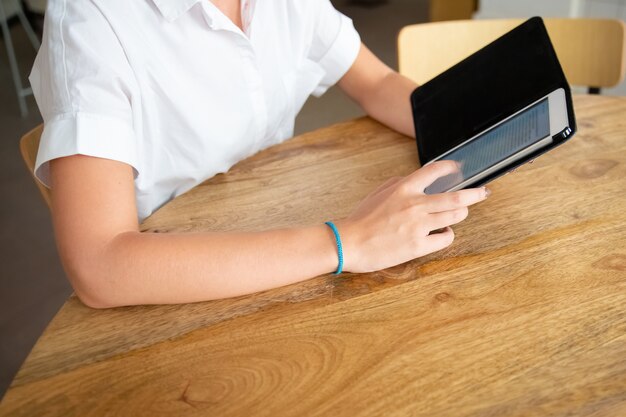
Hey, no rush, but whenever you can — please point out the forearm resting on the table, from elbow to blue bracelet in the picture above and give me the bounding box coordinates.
[75,225,337,307]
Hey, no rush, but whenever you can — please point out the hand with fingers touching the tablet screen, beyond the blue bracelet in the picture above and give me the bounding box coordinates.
[335,161,489,272]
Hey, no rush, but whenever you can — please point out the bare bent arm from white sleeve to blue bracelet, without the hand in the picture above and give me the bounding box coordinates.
[51,155,337,307]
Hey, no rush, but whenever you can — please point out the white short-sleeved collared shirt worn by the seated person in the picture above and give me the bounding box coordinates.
[30,0,360,221]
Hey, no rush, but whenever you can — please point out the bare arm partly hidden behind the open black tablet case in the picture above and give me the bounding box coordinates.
[339,44,417,137]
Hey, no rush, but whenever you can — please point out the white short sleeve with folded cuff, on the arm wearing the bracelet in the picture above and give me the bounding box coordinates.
[29,0,139,186]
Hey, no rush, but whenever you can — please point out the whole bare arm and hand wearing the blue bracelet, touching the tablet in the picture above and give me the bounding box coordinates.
[50,155,485,308]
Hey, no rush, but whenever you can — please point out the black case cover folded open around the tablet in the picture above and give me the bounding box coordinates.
[411,17,576,188]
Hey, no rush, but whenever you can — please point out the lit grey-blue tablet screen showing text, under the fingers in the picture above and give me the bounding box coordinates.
[424,98,550,194]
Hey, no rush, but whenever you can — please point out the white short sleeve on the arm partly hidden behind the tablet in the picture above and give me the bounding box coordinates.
[309,0,361,97]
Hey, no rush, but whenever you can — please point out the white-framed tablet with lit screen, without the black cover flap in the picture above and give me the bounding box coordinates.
[424,88,571,194]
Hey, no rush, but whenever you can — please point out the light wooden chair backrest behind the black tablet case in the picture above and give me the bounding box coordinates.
[398,19,626,94]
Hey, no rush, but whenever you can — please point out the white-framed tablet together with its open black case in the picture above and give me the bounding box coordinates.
[411,17,576,194]
